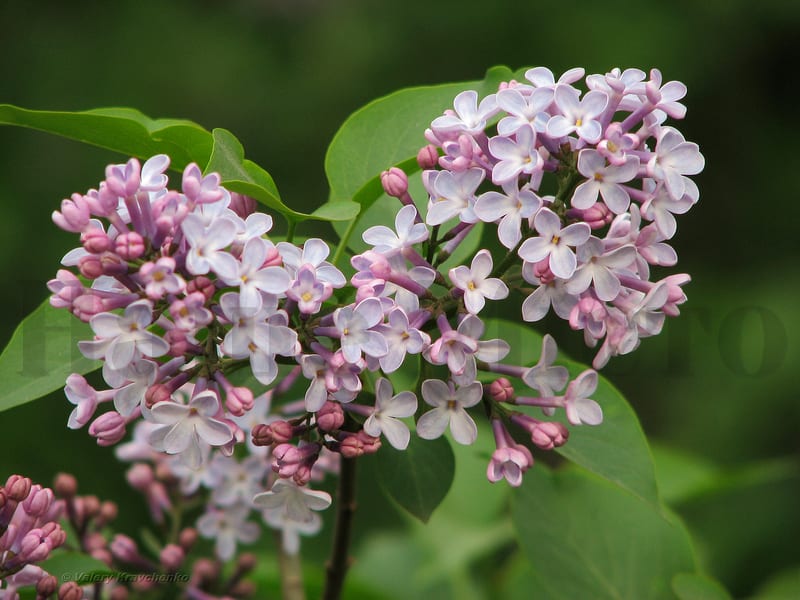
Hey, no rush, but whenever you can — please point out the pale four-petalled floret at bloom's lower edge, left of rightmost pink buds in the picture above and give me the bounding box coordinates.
[417,379,483,445]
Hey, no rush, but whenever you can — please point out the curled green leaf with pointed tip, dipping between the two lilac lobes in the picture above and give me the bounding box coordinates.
[204,129,358,221]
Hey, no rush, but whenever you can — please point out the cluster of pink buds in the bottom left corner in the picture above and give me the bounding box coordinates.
[0,475,66,598]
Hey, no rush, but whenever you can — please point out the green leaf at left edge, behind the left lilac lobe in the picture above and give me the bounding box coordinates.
[0,301,100,411]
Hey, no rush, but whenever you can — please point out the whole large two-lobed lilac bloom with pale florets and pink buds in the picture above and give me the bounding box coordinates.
[49,68,703,559]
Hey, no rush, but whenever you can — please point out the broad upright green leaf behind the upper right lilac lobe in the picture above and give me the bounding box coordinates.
[325,67,514,255]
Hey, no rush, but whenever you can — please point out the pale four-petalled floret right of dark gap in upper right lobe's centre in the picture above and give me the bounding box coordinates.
[571,150,639,215]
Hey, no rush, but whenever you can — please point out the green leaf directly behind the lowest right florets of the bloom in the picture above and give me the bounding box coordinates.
[481,319,659,506]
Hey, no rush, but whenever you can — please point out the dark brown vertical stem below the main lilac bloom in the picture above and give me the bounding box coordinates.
[322,457,356,600]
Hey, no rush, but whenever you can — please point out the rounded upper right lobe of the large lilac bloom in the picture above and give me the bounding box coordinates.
[420,67,704,368]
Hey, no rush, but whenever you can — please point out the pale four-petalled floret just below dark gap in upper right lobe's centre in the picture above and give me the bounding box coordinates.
[518,208,591,279]
